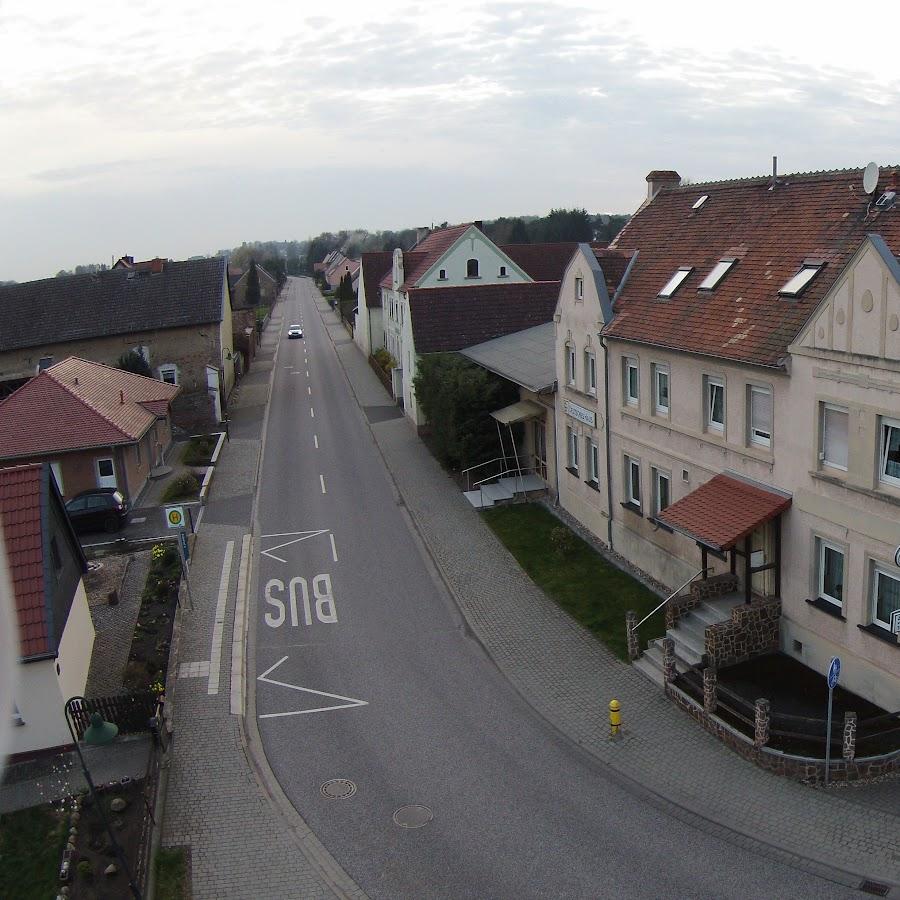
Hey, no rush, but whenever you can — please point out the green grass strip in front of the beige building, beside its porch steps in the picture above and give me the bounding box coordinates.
[483,503,665,660]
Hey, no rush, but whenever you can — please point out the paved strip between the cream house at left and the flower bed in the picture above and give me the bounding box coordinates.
[84,550,150,697]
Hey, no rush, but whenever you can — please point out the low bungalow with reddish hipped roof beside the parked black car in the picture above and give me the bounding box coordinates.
[0,357,181,504]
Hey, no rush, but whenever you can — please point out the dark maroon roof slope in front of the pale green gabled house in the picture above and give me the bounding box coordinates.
[409,281,559,353]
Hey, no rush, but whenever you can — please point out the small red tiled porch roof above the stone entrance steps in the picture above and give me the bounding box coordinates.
[657,475,791,550]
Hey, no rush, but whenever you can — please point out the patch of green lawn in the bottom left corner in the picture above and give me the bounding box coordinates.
[0,805,67,900]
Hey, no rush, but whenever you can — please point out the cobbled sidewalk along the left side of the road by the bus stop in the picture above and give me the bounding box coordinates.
[163,306,342,900]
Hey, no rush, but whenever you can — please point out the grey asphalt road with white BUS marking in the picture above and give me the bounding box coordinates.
[249,279,851,898]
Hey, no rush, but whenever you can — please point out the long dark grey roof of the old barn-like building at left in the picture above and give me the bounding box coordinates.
[0,257,225,351]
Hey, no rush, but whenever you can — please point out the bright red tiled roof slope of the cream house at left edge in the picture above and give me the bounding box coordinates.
[0,464,48,657]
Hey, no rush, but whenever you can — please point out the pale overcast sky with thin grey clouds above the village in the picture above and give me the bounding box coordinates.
[0,0,900,281]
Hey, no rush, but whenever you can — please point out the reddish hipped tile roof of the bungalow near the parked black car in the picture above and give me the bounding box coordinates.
[0,357,181,459]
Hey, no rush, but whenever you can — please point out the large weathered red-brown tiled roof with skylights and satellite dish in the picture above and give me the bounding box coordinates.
[605,169,900,366]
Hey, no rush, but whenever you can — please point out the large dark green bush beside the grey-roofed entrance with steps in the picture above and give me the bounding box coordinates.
[413,353,519,469]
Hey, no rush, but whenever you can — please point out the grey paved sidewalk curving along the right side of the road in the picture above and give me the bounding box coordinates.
[318,292,900,887]
